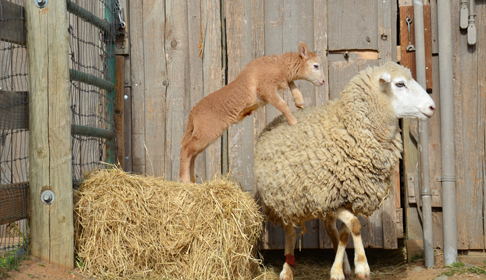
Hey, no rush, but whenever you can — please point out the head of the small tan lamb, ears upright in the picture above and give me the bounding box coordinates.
[299,42,325,86]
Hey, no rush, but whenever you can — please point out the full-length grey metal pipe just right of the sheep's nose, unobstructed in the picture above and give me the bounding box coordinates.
[437,0,457,265]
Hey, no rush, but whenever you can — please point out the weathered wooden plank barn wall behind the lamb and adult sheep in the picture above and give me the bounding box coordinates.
[128,0,403,249]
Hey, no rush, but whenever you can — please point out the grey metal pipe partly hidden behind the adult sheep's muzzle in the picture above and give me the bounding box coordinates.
[413,0,434,267]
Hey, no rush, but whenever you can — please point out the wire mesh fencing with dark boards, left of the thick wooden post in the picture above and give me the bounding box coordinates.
[0,0,29,270]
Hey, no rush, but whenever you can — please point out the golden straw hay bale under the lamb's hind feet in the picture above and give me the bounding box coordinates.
[74,168,263,279]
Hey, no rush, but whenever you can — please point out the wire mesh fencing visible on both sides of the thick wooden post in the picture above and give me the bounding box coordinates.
[0,0,118,272]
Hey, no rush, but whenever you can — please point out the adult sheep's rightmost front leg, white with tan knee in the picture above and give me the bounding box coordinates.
[337,207,370,280]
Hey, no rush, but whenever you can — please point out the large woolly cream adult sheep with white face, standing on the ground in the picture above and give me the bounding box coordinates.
[254,63,435,279]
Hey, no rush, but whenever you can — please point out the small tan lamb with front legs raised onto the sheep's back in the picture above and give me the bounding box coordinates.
[179,40,324,183]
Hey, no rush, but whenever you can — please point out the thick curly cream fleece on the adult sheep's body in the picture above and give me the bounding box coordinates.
[254,63,406,228]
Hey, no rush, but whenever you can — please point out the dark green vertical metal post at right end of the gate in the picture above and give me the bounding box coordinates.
[105,0,116,164]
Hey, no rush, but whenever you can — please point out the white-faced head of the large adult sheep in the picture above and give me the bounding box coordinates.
[377,62,435,121]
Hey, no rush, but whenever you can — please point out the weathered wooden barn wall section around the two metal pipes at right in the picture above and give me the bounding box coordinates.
[399,0,486,251]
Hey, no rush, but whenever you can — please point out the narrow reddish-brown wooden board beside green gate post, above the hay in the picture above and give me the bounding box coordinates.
[115,55,125,170]
